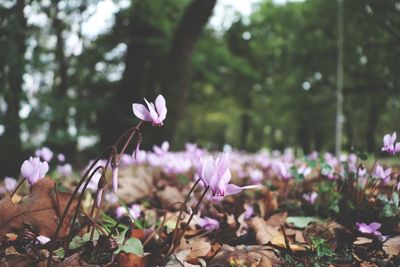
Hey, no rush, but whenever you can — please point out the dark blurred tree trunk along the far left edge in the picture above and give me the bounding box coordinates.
[0,0,27,176]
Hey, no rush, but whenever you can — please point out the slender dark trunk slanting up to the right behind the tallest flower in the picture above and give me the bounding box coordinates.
[158,0,217,146]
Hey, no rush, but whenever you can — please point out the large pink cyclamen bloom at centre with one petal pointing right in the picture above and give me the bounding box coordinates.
[200,154,259,198]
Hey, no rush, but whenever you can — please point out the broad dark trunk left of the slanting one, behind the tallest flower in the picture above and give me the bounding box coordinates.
[98,2,164,147]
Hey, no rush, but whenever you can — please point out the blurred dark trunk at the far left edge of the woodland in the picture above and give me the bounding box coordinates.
[0,0,26,177]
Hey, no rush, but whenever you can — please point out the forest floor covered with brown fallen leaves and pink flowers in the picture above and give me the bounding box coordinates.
[0,148,400,267]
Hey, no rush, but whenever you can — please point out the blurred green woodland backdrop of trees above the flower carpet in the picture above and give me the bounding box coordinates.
[0,0,400,176]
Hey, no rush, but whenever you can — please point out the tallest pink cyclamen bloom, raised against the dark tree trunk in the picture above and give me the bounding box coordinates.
[132,95,167,126]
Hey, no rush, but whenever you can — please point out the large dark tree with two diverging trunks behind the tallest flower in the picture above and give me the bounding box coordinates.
[99,0,216,149]
